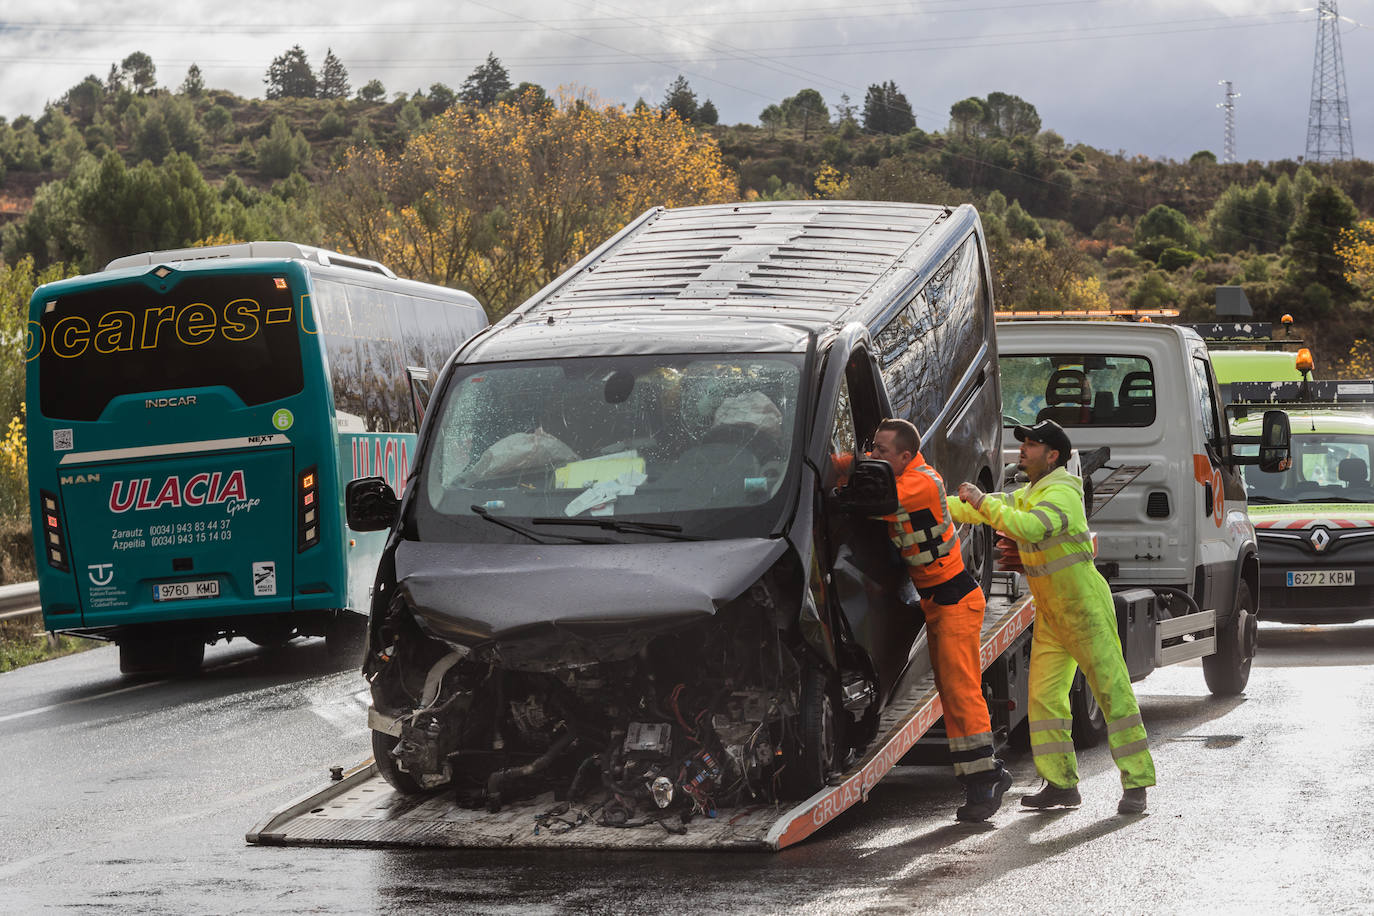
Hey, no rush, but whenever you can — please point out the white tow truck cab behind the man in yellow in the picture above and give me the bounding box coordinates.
[998,321,1287,695]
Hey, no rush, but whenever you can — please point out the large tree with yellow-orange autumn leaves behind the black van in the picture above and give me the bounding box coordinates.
[322,92,739,319]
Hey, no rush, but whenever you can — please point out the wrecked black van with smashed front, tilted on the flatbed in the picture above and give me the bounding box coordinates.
[348,202,1002,824]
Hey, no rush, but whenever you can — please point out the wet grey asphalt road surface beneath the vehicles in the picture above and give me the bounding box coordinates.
[0,626,1374,913]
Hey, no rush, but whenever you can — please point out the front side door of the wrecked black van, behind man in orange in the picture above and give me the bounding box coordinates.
[823,349,922,694]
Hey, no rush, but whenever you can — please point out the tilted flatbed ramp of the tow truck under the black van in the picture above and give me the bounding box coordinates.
[247,597,1035,851]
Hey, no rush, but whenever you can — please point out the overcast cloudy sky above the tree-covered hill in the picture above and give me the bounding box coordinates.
[0,0,1374,161]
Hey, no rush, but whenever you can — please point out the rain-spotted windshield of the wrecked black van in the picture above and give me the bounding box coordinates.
[415,353,804,542]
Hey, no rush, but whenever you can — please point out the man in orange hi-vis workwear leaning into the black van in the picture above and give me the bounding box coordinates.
[868,420,1011,821]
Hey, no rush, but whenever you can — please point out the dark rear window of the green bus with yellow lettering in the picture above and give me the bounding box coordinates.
[30,275,302,420]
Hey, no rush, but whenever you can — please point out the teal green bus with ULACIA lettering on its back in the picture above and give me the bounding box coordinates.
[25,242,488,673]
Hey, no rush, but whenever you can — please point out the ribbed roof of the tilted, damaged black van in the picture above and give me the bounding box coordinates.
[502,201,961,330]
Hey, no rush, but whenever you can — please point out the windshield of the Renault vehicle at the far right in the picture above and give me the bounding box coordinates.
[1237,431,1374,504]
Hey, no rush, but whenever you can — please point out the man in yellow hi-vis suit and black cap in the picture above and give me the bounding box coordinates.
[949,420,1154,814]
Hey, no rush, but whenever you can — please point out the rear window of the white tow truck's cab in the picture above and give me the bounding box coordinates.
[998,353,1154,426]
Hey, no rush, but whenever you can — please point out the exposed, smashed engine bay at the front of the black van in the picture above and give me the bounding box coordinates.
[370,581,877,831]
